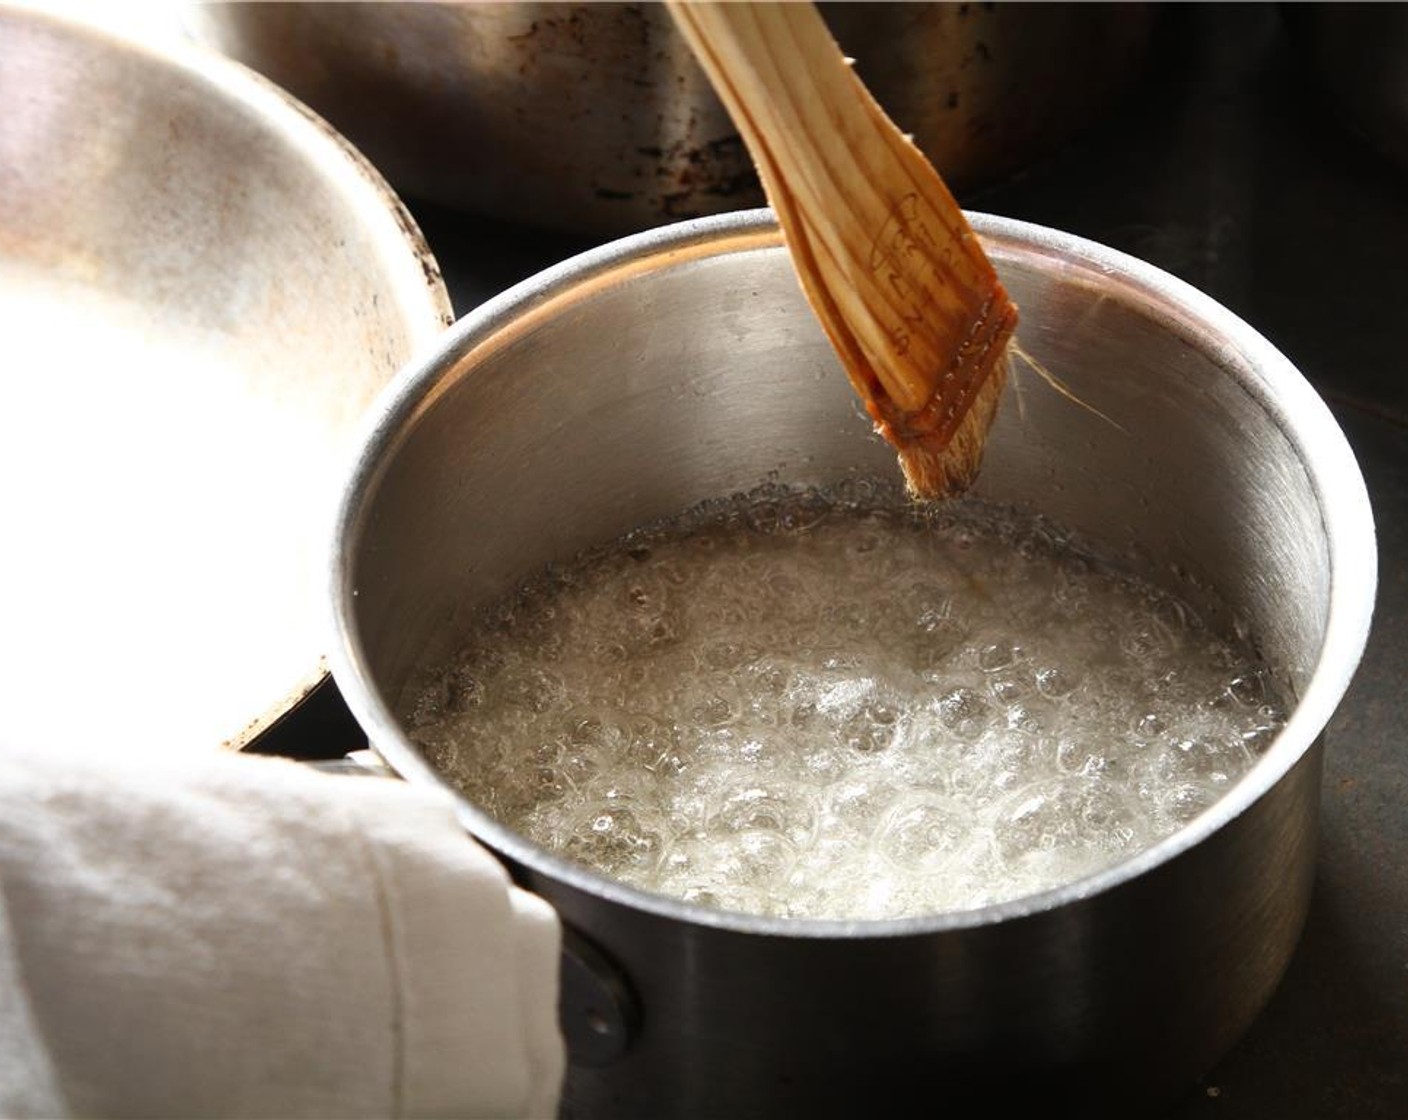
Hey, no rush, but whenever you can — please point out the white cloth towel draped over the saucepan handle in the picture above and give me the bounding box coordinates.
[0,745,565,1117]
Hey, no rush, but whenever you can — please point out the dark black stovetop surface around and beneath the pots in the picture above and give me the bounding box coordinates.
[261,4,1408,1120]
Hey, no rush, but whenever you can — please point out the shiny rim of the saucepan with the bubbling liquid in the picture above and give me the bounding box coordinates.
[328,209,1377,938]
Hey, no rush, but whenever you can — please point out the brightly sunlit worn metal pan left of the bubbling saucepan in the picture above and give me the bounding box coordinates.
[0,8,449,749]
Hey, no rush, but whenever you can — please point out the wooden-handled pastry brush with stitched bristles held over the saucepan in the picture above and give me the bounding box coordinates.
[669,0,1017,497]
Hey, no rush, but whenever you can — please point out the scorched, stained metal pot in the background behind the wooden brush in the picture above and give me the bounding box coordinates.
[191,3,1152,232]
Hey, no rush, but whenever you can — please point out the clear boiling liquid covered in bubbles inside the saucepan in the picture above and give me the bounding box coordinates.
[403,483,1284,919]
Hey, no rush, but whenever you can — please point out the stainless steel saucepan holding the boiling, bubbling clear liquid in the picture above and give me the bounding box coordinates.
[331,211,1374,1117]
